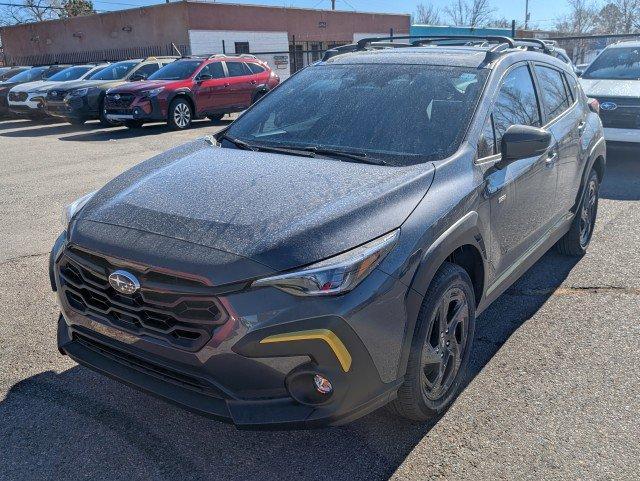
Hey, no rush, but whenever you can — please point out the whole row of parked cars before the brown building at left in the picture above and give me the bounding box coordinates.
[0,55,280,129]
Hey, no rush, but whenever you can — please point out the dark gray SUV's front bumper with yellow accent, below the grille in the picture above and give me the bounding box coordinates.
[50,237,409,429]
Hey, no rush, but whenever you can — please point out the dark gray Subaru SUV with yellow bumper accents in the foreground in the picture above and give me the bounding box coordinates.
[50,37,605,427]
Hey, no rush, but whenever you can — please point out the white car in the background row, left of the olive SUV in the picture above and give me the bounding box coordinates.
[7,63,109,116]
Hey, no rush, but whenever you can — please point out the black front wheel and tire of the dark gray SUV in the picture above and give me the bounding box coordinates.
[388,262,476,421]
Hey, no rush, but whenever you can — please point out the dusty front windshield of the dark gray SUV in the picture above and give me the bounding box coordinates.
[226,65,487,165]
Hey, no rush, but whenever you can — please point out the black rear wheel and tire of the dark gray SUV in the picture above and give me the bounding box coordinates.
[556,170,600,257]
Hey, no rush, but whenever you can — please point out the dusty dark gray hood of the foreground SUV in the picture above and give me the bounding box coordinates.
[71,140,435,281]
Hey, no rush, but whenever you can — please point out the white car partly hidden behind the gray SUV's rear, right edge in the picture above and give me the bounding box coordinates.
[580,41,640,144]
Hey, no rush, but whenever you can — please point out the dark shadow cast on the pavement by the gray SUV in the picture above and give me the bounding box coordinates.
[0,249,576,480]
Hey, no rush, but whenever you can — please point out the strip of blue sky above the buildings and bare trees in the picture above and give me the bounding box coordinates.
[93,0,568,28]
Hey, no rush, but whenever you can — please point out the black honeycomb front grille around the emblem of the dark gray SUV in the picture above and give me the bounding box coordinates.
[57,248,228,351]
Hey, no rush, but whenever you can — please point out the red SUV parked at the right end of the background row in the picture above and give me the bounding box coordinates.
[104,55,280,129]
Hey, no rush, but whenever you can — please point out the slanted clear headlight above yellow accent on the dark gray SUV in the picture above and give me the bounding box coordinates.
[253,230,400,296]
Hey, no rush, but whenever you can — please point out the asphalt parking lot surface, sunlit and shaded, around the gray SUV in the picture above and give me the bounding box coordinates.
[0,120,640,481]
